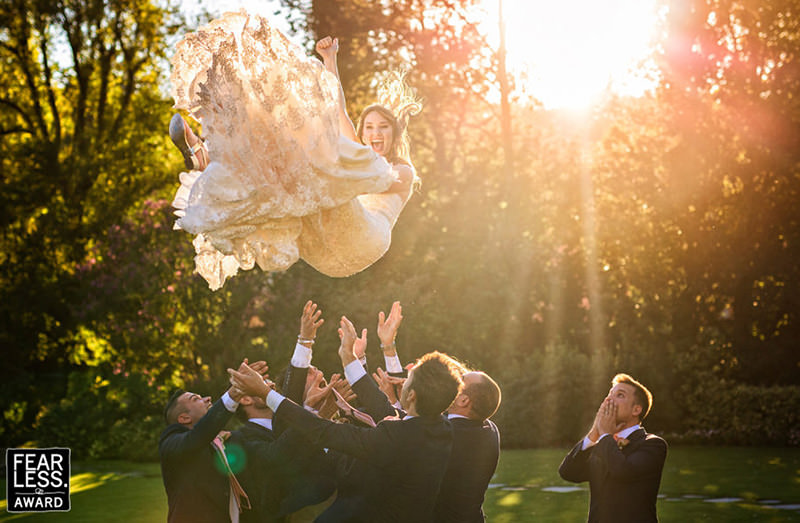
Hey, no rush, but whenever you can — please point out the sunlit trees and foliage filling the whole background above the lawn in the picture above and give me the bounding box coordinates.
[0,0,800,458]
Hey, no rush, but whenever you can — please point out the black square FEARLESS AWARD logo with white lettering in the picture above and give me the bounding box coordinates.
[6,448,70,512]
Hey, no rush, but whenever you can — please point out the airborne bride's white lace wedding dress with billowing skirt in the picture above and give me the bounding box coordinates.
[171,12,403,289]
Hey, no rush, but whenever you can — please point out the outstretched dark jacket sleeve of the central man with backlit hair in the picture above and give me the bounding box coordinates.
[275,400,399,465]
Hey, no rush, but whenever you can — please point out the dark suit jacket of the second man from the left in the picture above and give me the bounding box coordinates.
[225,421,335,523]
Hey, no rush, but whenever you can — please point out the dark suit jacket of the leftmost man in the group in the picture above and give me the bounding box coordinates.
[158,400,233,523]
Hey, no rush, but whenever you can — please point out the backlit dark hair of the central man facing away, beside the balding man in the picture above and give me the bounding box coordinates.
[409,351,463,416]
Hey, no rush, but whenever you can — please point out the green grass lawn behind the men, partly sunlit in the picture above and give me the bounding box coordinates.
[0,447,800,523]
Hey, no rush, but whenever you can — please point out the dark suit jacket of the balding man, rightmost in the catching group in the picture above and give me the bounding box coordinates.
[436,418,500,523]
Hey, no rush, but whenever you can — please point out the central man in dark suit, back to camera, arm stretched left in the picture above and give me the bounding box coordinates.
[228,318,462,522]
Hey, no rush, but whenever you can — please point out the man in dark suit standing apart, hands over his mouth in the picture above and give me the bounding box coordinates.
[558,374,667,523]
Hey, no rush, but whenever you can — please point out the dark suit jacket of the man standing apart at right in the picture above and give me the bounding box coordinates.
[558,429,667,523]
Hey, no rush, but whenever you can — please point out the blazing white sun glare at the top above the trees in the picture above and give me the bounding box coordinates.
[481,0,658,109]
